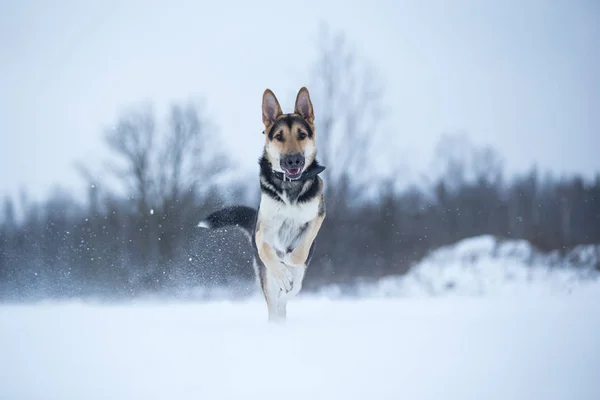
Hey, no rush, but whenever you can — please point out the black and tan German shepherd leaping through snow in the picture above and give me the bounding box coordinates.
[198,87,326,321]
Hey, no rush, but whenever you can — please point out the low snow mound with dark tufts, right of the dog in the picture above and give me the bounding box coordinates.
[320,235,600,297]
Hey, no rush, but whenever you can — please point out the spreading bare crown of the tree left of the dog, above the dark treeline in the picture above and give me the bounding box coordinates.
[106,103,226,215]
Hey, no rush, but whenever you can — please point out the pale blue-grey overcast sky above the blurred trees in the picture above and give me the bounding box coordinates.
[0,0,600,197]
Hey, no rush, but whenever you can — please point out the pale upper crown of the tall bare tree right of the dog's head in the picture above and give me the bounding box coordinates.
[311,27,383,203]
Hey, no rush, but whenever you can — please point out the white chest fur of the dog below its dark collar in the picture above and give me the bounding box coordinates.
[259,195,319,253]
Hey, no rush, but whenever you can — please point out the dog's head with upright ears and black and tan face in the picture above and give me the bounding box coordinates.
[262,87,317,180]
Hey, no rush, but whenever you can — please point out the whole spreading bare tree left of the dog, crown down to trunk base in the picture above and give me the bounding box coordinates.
[97,98,226,284]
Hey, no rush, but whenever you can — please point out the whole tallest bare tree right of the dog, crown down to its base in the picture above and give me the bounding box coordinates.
[308,26,383,280]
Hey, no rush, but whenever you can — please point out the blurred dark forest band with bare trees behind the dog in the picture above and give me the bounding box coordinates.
[0,28,600,301]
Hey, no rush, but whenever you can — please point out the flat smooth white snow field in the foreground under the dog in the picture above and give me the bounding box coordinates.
[0,284,600,400]
